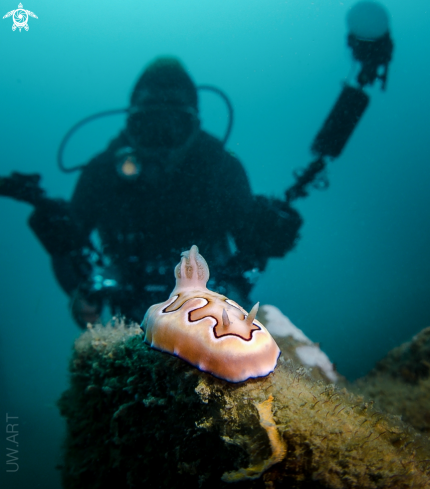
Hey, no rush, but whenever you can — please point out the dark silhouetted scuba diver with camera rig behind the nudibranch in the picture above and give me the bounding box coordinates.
[0,2,392,326]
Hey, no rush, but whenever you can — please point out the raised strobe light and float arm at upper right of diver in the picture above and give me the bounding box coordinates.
[286,1,394,202]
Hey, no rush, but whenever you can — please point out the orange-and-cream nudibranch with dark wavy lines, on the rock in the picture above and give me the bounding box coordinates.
[142,245,280,382]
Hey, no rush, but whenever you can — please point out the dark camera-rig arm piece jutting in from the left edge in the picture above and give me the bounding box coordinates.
[0,172,45,205]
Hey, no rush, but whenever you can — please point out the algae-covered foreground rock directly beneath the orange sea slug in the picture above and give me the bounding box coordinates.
[59,322,430,489]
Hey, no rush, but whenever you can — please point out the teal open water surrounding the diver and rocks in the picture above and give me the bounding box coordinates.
[0,0,430,489]
